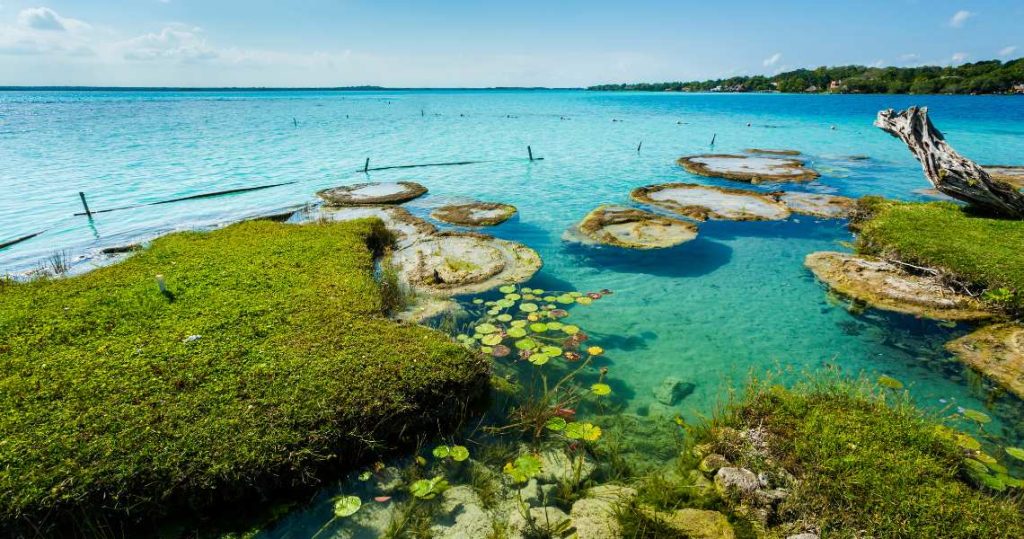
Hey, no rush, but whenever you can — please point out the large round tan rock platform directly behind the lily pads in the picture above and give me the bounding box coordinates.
[391,233,541,297]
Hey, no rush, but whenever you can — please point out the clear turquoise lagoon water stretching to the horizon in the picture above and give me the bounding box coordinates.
[0,90,1024,532]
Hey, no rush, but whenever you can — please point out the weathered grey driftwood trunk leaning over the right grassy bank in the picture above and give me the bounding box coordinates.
[874,107,1024,218]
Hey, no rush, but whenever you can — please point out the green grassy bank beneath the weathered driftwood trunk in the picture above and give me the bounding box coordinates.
[855,197,1024,312]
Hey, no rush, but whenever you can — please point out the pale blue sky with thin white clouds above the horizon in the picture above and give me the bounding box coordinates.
[0,0,1024,87]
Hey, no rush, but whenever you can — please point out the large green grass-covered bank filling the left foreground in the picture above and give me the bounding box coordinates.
[0,219,487,533]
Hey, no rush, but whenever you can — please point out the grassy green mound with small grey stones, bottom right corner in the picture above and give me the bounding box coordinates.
[702,382,1024,538]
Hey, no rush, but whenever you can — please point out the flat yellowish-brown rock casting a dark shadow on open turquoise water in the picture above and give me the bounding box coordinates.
[575,206,697,249]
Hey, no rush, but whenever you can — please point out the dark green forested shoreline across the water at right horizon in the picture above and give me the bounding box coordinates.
[588,58,1024,93]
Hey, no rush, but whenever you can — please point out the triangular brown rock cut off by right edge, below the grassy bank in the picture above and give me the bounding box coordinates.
[946,324,1024,399]
